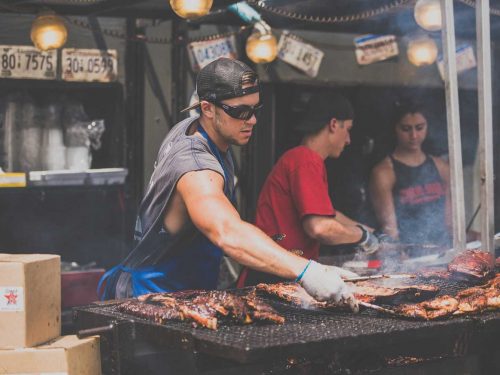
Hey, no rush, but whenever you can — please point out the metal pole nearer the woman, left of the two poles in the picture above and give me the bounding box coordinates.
[441,0,465,251]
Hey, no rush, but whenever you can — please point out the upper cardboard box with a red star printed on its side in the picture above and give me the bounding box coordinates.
[0,254,61,348]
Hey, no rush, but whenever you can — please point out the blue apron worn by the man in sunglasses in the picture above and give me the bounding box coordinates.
[97,125,234,299]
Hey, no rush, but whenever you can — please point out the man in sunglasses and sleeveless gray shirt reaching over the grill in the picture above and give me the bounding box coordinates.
[99,58,357,309]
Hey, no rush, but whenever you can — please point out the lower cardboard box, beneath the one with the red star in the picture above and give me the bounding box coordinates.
[0,336,101,375]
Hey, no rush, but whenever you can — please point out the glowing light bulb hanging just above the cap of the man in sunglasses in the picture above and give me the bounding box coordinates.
[245,21,278,64]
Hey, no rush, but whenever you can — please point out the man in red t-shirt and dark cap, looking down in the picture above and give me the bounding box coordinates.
[238,92,380,286]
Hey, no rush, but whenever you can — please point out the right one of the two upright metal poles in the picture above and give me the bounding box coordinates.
[476,0,495,255]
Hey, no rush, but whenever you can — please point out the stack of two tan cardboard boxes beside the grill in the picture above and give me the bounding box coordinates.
[0,254,101,375]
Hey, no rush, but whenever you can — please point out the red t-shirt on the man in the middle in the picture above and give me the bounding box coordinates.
[255,146,335,260]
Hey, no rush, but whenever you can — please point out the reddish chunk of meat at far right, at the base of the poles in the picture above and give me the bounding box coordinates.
[448,250,495,279]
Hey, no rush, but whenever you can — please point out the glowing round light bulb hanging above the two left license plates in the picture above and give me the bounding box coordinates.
[31,12,68,51]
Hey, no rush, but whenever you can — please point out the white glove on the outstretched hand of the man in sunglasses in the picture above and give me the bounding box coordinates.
[300,261,359,312]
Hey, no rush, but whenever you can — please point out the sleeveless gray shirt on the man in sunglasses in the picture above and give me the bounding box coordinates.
[115,116,234,298]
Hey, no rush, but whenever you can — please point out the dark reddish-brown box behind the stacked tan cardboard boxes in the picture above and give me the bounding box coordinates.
[61,268,104,309]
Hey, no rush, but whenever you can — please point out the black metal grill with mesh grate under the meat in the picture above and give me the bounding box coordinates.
[74,279,500,374]
